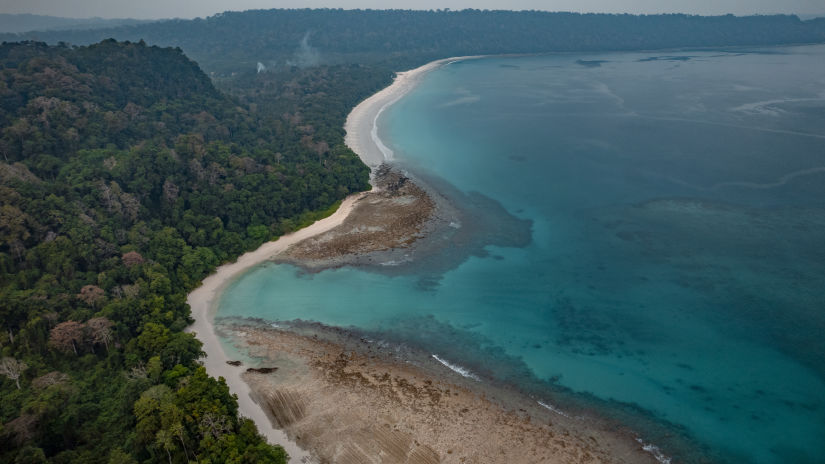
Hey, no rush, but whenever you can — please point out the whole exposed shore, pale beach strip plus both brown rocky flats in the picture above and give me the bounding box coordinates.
[183,58,657,463]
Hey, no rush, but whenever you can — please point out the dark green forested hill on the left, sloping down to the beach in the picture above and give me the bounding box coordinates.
[0,40,368,463]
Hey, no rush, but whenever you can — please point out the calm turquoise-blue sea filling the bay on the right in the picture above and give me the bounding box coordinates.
[218,46,825,463]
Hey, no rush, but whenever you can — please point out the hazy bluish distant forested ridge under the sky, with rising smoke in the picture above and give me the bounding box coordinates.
[0,9,825,75]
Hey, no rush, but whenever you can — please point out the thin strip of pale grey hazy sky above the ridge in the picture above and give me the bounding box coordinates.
[0,0,825,19]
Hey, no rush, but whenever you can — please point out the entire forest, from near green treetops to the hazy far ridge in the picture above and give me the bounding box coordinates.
[0,10,825,463]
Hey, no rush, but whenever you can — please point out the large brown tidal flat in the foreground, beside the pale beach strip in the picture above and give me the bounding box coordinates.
[217,319,655,464]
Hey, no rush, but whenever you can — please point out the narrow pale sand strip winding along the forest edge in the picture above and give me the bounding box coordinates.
[187,57,473,463]
